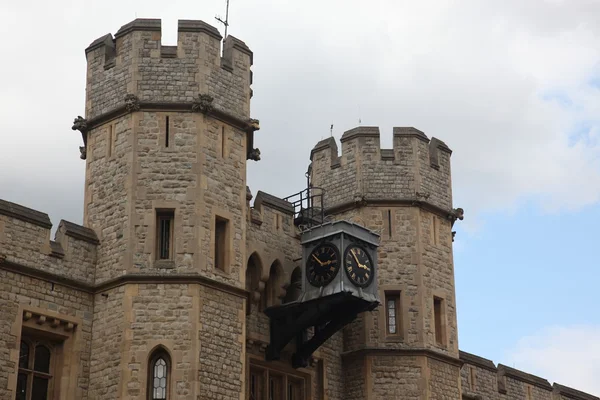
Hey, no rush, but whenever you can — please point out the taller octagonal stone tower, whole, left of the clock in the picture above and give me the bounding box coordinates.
[79,19,258,400]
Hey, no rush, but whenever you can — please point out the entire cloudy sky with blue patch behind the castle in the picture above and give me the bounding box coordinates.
[0,0,600,395]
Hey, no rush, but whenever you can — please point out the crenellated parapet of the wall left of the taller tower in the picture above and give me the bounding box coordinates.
[0,200,100,285]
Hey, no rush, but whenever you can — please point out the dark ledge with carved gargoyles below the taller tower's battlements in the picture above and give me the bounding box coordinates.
[71,94,260,161]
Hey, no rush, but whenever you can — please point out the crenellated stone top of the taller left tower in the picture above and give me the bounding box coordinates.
[85,19,253,119]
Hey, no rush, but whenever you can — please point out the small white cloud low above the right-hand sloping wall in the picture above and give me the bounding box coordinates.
[508,326,600,396]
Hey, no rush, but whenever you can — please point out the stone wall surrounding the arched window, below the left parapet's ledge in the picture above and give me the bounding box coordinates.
[0,263,93,399]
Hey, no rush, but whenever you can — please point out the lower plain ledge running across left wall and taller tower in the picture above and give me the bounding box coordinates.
[0,254,250,300]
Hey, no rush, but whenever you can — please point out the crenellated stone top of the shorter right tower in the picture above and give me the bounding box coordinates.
[311,126,452,210]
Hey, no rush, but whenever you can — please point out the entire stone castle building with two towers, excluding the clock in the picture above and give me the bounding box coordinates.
[0,19,598,400]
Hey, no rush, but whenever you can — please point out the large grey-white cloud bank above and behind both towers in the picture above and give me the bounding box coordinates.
[0,0,600,223]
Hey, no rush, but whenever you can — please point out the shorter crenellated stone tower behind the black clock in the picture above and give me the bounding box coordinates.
[311,127,461,399]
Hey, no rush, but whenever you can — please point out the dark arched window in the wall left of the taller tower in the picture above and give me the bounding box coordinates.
[16,339,54,400]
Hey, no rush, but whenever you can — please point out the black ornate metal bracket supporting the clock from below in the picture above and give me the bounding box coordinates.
[265,292,379,368]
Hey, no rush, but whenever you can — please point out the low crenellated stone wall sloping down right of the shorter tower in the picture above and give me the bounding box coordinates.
[459,351,600,400]
